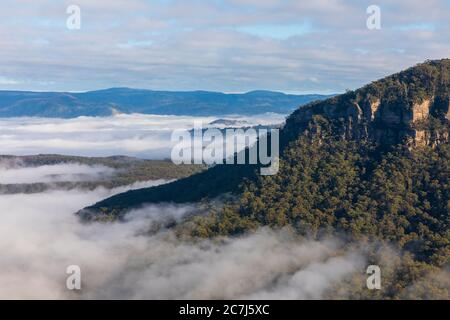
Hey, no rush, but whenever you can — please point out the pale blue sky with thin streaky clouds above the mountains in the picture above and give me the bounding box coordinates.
[0,0,450,93]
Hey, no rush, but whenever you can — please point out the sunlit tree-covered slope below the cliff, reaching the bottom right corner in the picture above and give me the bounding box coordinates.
[181,119,450,299]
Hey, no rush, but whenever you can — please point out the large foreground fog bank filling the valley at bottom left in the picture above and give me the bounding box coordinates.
[0,165,365,299]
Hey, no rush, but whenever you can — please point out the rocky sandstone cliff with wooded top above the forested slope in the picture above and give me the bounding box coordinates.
[286,59,450,147]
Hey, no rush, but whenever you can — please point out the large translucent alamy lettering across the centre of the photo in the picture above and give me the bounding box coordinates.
[171,121,280,175]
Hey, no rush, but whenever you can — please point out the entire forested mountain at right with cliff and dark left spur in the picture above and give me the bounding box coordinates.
[79,59,450,299]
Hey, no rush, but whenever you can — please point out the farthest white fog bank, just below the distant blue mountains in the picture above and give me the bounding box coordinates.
[0,113,285,159]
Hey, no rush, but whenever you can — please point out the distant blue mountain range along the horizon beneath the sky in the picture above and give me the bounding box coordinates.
[0,88,329,118]
